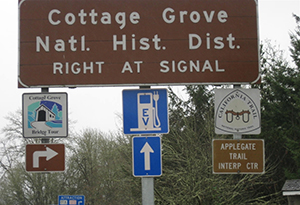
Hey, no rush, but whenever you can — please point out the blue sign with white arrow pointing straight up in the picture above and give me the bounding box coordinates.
[132,136,162,177]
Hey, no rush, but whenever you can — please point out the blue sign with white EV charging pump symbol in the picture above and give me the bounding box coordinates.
[123,89,169,134]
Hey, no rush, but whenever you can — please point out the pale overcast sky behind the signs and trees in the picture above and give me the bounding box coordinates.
[0,0,300,139]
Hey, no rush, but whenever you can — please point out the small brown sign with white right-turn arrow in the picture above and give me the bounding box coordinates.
[26,144,65,172]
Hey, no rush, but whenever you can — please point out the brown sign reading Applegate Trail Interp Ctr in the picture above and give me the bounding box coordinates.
[212,139,265,174]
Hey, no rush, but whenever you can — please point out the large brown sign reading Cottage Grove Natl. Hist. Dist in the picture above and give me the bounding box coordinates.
[18,0,259,87]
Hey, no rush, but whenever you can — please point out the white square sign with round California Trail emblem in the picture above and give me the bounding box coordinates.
[215,89,261,135]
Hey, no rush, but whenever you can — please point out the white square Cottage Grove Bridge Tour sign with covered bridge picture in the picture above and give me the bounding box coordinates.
[22,93,68,138]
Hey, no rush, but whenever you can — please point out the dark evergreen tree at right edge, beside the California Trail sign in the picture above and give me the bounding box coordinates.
[260,16,300,181]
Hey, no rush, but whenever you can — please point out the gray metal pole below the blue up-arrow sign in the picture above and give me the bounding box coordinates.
[142,177,154,205]
